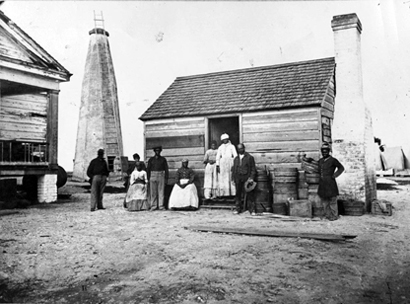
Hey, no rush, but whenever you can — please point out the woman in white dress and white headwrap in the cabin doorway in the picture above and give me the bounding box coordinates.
[216,133,238,196]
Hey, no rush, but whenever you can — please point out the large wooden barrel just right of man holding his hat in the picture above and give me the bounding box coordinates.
[270,168,299,215]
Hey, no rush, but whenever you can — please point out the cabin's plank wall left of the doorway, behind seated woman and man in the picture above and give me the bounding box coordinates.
[145,117,206,195]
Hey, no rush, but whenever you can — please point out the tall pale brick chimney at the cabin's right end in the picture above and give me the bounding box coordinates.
[332,14,376,211]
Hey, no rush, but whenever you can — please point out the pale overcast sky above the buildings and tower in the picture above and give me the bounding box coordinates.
[0,0,410,171]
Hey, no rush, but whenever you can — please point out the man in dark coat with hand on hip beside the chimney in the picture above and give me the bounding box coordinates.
[317,143,345,221]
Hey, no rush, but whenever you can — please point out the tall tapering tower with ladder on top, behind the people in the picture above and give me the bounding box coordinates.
[73,13,123,181]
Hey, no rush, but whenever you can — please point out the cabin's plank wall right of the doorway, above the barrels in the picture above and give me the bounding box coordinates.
[242,107,321,170]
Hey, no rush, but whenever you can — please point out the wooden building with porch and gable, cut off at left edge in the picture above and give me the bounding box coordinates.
[0,11,71,202]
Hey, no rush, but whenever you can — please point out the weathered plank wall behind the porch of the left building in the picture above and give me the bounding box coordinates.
[0,94,48,142]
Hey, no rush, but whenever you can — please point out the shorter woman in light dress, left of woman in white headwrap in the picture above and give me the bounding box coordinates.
[204,141,218,199]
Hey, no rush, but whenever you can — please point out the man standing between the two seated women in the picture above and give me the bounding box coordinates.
[147,146,169,211]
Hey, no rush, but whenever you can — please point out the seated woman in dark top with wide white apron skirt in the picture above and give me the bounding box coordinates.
[168,159,199,210]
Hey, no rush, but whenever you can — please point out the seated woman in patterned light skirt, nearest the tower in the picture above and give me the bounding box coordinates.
[124,162,149,211]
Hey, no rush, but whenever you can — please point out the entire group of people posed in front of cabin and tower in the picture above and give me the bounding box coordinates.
[87,133,344,220]
